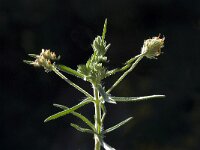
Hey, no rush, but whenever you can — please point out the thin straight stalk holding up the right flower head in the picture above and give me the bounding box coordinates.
[106,55,144,93]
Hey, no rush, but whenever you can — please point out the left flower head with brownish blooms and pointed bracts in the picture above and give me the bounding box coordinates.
[24,49,60,72]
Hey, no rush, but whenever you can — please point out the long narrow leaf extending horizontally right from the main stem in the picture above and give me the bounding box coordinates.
[111,95,165,102]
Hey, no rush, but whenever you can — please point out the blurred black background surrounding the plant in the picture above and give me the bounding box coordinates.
[0,0,200,150]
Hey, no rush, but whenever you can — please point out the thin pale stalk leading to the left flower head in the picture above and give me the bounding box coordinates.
[52,67,93,98]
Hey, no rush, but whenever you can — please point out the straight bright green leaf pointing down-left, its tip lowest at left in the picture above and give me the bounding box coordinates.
[44,100,91,122]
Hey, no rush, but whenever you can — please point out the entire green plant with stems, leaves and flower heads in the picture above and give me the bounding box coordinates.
[24,20,165,150]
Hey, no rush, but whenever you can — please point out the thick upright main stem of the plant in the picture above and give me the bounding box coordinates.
[93,85,102,150]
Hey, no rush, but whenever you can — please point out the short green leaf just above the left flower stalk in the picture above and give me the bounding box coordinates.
[56,65,84,79]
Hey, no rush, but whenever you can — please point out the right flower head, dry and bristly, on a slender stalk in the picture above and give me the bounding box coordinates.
[141,35,165,59]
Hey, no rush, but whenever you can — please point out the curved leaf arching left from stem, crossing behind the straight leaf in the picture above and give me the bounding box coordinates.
[53,104,95,131]
